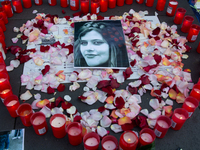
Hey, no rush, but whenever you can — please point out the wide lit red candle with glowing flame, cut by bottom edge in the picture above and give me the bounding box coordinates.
[119,131,138,150]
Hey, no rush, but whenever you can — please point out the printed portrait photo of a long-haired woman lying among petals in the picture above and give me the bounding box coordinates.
[74,20,129,68]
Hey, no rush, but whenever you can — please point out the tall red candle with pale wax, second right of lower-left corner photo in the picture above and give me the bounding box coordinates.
[50,114,67,138]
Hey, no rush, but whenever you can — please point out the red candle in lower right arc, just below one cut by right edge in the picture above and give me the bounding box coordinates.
[182,96,199,118]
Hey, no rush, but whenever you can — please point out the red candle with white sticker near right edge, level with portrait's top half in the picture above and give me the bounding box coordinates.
[186,24,200,42]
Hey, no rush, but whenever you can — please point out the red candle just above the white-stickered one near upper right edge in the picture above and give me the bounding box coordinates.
[181,16,194,33]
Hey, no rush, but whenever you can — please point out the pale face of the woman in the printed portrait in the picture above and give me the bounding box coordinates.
[80,30,109,67]
